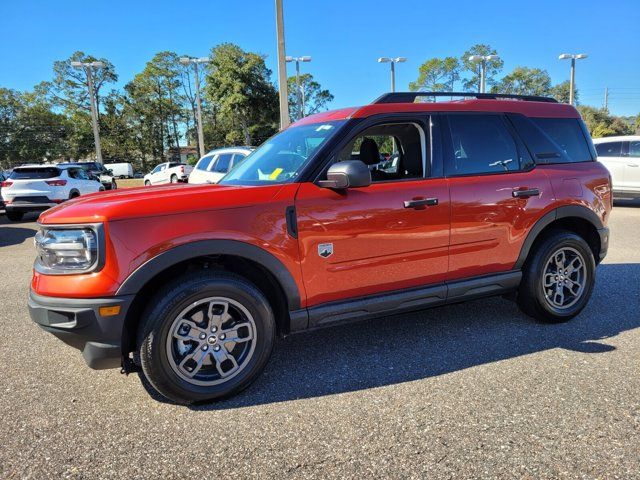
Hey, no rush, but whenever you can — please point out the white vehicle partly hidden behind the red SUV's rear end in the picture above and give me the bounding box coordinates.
[593,135,640,198]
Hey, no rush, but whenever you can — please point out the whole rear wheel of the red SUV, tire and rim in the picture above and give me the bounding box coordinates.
[518,230,596,323]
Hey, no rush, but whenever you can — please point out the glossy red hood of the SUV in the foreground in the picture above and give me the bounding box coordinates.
[39,184,283,224]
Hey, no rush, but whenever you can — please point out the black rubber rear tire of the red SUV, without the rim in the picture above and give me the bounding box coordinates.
[532,233,596,322]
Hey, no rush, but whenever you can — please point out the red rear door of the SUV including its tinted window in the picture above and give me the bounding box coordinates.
[443,113,553,280]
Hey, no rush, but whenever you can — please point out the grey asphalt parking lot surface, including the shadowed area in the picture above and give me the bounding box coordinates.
[0,203,640,479]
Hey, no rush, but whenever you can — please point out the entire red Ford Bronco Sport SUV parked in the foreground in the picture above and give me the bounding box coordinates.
[28,93,612,403]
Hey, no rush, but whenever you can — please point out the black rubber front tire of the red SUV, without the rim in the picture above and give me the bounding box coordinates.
[140,277,275,403]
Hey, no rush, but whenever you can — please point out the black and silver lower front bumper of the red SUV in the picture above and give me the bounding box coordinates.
[29,291,134,369]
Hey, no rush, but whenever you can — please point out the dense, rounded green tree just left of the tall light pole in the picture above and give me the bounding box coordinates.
[205,43,278,145]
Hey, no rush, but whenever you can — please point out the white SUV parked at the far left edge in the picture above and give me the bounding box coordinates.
[2,164,104,221]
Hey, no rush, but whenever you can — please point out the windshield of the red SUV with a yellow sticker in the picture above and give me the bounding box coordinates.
[220,120,344,185]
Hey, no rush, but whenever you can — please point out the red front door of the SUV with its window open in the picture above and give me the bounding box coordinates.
[295,121,449,306]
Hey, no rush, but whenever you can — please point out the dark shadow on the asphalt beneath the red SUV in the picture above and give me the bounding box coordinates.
[136,264,640,410]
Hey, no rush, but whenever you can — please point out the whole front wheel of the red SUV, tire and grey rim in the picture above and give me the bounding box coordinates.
[137,271,275,404]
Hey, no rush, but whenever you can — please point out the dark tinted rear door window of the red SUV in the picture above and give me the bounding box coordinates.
[445,114,520,175]
